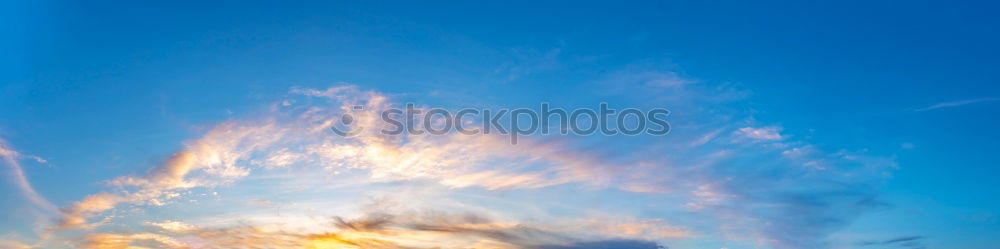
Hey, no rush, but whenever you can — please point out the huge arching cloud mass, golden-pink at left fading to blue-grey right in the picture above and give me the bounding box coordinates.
[43,80,895,248]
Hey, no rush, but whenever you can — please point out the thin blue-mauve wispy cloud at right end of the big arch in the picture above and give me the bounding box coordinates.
[584,65,897,248]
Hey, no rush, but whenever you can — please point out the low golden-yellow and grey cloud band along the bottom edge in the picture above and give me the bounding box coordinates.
[78,207,662,249]
